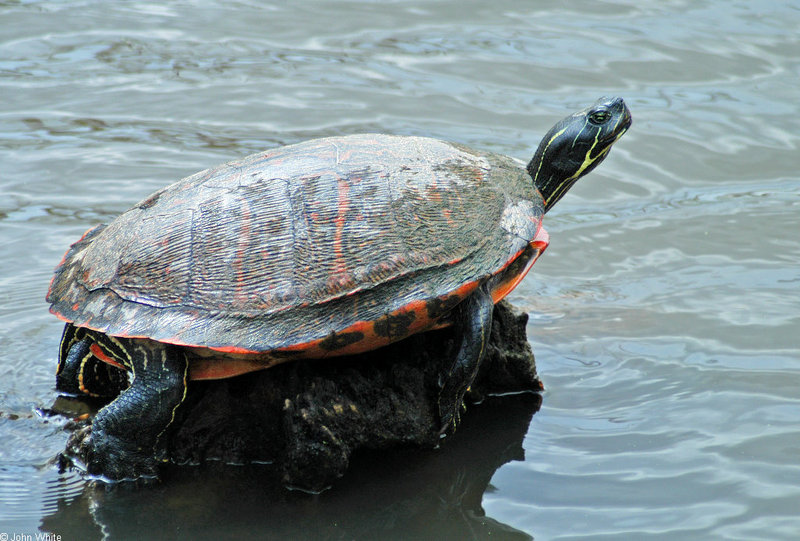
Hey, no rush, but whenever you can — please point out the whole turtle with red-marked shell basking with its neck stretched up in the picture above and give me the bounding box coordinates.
[47,97,631,482]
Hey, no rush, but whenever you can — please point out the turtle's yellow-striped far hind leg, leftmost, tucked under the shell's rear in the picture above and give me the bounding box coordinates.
[56,323,128,399]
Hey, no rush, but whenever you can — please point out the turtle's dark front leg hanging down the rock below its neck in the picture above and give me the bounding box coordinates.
[438,284,494,435]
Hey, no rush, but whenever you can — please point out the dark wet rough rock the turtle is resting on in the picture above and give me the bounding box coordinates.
[59,302,542,491]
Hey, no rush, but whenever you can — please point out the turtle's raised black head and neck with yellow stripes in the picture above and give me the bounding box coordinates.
[527,98,631,212]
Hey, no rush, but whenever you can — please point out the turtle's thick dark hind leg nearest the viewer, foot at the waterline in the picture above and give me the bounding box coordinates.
[80,334,188,481]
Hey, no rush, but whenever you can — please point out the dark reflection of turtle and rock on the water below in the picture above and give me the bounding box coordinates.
[40,393,541,540]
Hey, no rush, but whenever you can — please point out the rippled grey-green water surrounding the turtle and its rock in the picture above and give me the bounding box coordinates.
[0,0,800,540]
